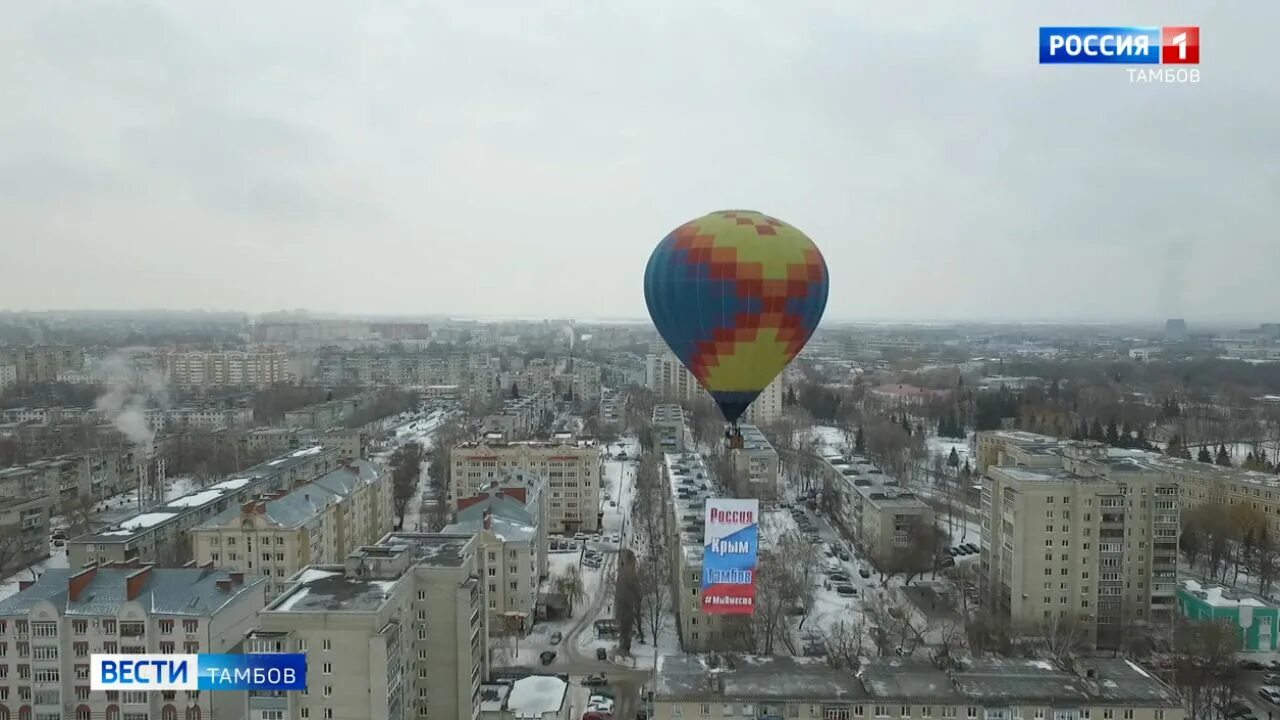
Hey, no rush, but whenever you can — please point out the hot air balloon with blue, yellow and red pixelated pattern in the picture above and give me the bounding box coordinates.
[644,210,827,443]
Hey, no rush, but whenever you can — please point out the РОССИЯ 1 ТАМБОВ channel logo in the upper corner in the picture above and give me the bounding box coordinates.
[1039,26,1199,82]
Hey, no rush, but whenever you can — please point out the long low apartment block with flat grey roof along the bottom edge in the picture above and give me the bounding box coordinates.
[653,655,1185,720]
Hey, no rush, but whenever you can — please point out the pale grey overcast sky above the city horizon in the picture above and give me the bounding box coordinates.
[0,0,1280,322]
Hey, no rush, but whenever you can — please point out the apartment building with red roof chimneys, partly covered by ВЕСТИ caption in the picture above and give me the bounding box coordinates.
[0,566,265,720]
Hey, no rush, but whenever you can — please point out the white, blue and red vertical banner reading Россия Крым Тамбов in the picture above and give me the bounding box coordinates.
[703,498,760,615]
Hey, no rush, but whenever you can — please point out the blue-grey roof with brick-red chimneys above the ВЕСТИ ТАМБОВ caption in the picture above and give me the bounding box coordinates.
[0,566,266,616]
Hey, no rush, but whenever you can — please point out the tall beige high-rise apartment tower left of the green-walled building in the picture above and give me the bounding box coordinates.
[979,441,1180,648]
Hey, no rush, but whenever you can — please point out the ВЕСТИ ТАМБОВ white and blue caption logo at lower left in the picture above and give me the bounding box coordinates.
[88,652,307,691]
